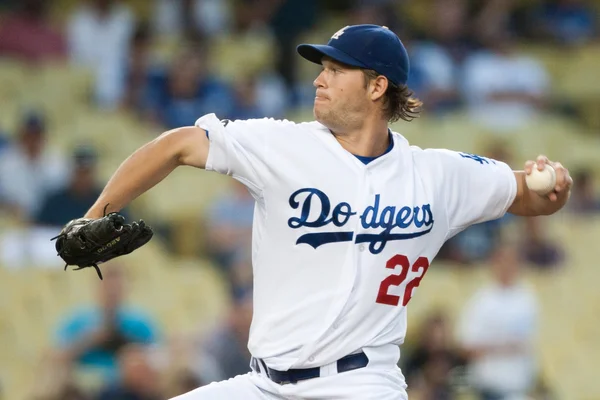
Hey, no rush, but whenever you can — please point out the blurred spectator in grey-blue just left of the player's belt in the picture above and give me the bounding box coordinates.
[192,293,252,382]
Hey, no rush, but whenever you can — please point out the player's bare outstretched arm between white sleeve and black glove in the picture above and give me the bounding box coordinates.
[85,126,209,218]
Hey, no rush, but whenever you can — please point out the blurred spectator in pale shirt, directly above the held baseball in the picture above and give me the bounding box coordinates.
[462,25,549,130]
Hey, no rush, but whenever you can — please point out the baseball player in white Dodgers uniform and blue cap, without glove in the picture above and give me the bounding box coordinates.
[77,25,572,400]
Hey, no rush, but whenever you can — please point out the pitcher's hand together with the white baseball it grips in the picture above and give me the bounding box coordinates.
[525,156,573,201]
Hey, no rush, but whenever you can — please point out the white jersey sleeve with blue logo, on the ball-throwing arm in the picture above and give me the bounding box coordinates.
[434,150,517,238]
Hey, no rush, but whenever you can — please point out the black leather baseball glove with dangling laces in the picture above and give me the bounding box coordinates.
[51,213,153,279]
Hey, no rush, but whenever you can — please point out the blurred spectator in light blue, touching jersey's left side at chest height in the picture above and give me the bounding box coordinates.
[206,181,255,272]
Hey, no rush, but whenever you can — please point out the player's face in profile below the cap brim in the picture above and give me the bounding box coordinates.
[313,57,370,133]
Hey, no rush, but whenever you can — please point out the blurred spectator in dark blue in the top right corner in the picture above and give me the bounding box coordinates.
[531,0,598,46]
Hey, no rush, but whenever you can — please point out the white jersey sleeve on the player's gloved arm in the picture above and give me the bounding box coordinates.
[195,114,293,192]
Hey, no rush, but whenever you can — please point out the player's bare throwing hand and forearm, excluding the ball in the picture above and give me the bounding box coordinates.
[508,155,573,217]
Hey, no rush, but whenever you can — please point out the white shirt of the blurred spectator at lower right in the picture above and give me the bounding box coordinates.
[458,283,538,395]
